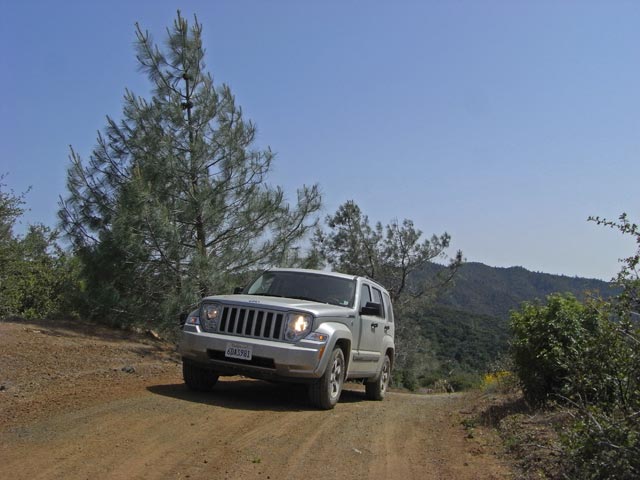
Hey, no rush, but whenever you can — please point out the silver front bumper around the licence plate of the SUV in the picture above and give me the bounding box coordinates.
[178,325,327,381]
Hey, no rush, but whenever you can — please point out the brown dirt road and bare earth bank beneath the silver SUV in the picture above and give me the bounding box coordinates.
[0,322,513,480]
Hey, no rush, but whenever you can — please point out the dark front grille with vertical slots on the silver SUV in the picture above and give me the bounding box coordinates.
[202,305,285,340]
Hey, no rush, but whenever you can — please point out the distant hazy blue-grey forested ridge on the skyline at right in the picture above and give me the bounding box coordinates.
[437,262,614,319]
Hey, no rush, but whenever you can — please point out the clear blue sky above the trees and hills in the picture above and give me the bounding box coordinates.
[0,0,640,279]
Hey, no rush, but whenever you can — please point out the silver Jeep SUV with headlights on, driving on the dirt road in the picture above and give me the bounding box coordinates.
[179,269,395,409]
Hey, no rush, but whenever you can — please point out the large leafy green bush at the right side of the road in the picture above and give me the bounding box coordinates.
[508,295,640,479]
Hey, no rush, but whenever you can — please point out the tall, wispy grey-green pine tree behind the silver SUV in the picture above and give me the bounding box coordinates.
[59,12,321,326]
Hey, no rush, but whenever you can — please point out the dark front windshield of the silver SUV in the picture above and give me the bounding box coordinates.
[245,272,356,307]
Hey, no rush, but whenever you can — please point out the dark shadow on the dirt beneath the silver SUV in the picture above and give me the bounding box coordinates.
[147,379,366,412]
